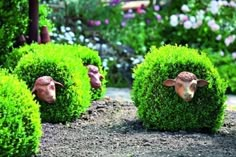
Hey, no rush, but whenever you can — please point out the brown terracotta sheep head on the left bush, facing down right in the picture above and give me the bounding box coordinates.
[32,76,63,104]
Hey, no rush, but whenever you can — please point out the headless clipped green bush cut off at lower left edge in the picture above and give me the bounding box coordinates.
[0,70,42,156]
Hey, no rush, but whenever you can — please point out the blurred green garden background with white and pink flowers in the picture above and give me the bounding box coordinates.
[0,0,236,93]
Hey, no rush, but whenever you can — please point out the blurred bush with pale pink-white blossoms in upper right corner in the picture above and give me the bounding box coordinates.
[162,0,236,53]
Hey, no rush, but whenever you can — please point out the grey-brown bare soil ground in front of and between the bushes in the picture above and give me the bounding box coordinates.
[36,98,236,157]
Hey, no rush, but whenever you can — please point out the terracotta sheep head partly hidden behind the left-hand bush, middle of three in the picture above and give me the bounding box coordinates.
[87,65,103,89]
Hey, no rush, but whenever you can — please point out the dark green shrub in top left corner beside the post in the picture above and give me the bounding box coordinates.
[0,0,28,63]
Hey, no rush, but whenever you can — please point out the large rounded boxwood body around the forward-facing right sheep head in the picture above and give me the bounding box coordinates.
[132,45,226,132]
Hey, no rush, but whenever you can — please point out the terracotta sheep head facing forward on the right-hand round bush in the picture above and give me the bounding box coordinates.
[163,71,208,102]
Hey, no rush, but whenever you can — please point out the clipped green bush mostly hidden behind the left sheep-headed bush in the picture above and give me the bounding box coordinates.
[4,43,106,100]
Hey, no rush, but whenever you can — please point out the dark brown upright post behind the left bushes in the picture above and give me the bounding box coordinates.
[28,0,39,43]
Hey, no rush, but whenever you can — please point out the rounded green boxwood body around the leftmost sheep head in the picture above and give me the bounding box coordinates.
[13,45,91,123]
